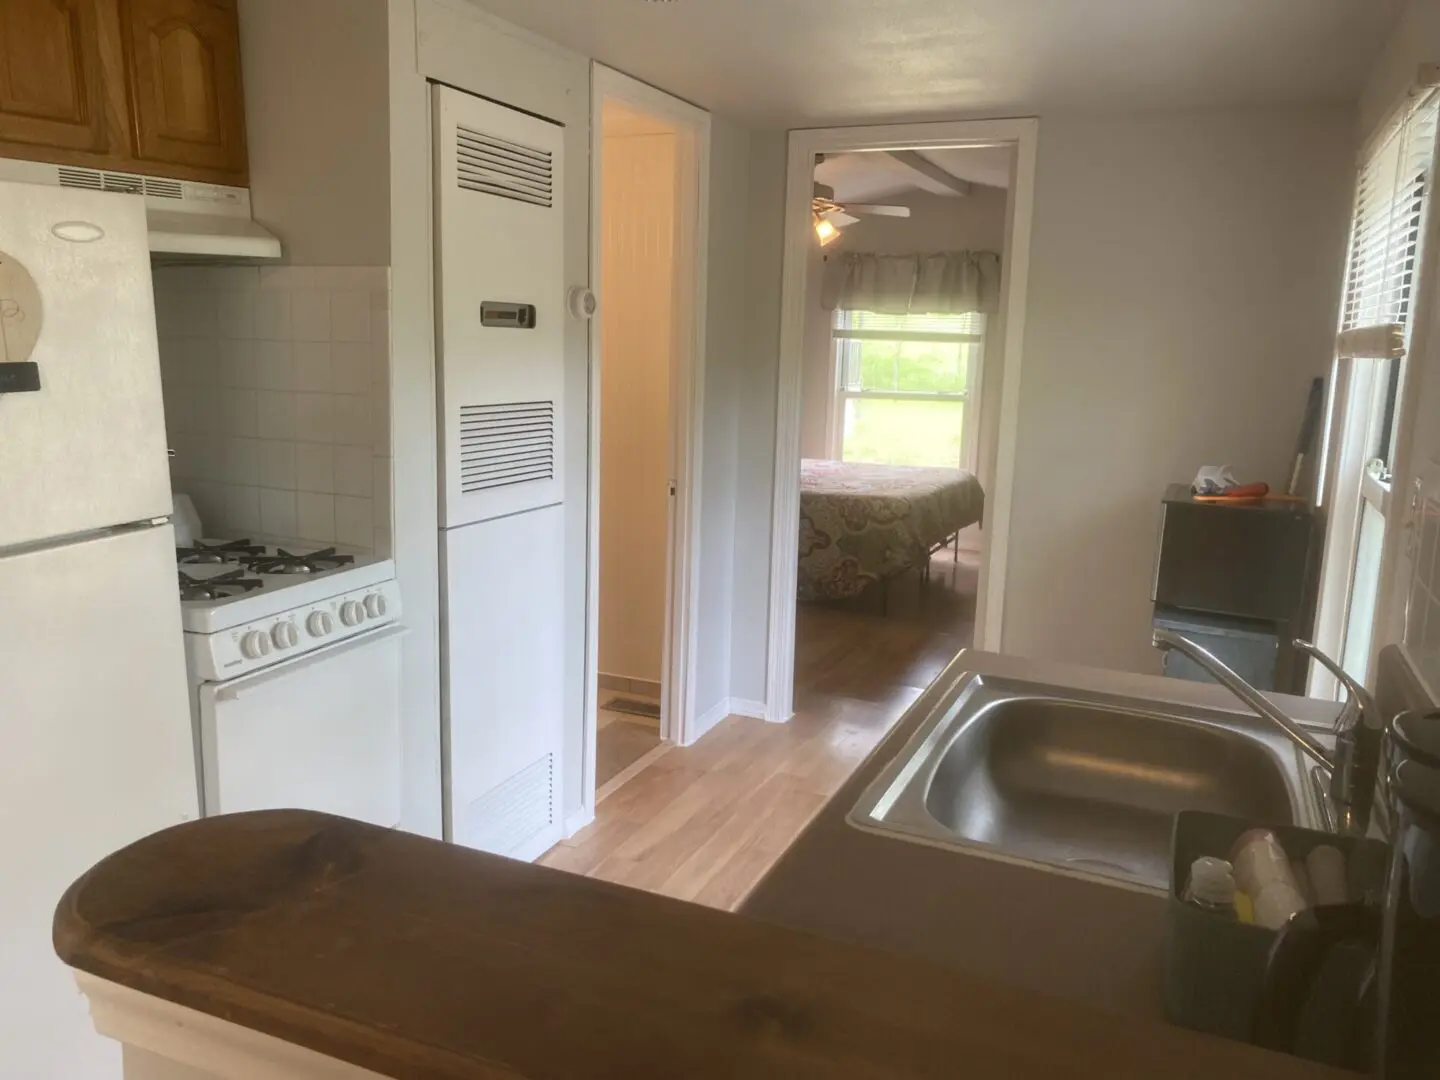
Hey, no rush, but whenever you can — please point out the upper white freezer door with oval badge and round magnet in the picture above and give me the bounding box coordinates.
[0,183,173,550]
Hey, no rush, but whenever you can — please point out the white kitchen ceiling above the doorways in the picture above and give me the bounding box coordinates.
[480,0,1404,127]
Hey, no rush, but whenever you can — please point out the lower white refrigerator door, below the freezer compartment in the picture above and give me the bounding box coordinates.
[0,526,199,1080]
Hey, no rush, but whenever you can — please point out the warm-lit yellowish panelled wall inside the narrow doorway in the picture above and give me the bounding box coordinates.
[599,124,677,683]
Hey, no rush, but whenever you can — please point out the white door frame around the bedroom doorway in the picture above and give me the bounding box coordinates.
[766,117,1040,721]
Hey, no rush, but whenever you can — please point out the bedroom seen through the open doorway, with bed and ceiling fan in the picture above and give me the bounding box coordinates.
[796,145,1012,708]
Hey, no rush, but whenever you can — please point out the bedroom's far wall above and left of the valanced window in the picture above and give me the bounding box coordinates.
[801,186,1009,458]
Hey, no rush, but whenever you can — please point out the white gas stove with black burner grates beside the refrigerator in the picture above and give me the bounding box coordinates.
[176,540,405,825]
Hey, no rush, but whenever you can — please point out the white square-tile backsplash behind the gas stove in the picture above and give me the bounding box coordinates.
[156,266,392,553]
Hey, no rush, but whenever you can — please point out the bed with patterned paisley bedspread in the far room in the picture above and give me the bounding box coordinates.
[799,458,985,600]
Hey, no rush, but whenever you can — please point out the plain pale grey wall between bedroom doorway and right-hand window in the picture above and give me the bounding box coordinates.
[1004,107,1355,671]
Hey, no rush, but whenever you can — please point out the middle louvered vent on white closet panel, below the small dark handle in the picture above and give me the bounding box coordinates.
[459,402,554,495]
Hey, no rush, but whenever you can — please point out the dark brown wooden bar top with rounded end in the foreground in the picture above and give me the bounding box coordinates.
[55,811,1348,1080]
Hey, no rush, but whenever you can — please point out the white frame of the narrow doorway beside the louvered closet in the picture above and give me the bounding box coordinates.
[583,63,710,816]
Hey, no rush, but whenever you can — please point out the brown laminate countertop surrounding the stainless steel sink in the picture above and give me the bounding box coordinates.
[740,651,1339,1020]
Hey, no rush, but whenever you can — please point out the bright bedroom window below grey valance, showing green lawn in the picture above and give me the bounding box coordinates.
[831,311,985,469]
